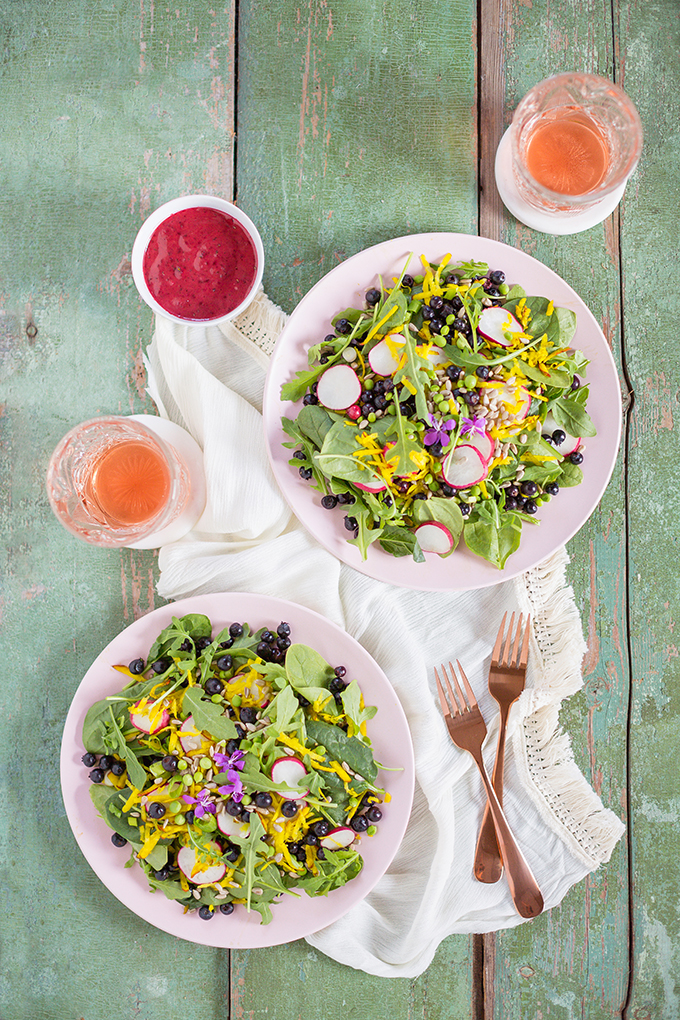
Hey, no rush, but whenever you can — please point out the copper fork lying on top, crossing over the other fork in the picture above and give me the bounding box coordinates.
[434,662,543,917]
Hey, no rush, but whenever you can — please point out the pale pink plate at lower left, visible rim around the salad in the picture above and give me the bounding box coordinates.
[61,593,414,949]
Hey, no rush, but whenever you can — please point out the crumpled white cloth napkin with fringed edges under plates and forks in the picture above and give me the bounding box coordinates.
[148,293,623,977]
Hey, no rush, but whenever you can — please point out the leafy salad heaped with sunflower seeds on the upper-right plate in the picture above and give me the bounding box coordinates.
[281,255,595,568]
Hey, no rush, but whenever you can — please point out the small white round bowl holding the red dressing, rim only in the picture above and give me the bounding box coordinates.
[132,195,264,325]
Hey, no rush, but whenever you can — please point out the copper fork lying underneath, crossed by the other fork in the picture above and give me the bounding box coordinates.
[474,613,531,882]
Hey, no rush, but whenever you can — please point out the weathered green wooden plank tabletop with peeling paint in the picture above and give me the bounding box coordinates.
[0,0,680,1020]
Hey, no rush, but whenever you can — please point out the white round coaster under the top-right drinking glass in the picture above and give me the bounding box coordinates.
[495,128,626,235]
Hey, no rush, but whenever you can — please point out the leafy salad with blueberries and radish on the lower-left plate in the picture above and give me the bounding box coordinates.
[83,614,389,924]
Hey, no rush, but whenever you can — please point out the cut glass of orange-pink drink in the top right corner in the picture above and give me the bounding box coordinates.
[510,72,642,214]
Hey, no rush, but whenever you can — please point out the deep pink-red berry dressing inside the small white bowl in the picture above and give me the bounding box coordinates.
[143,207,257,321]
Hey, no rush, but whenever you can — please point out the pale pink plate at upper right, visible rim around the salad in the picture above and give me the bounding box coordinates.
[264,234,621,591]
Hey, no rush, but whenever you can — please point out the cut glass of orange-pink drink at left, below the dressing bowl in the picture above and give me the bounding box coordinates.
[47,415,193,548]
